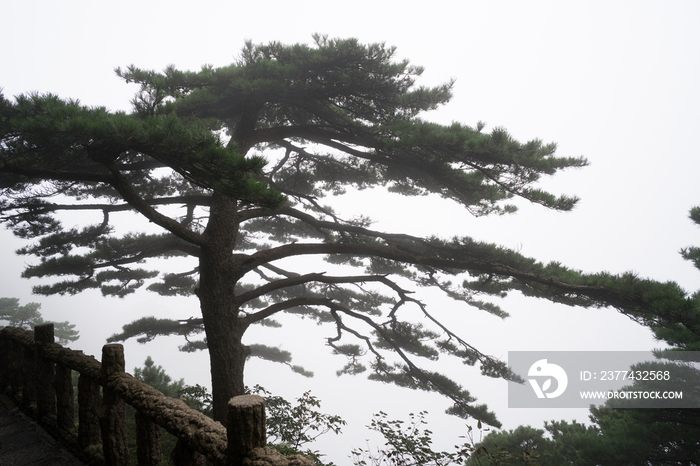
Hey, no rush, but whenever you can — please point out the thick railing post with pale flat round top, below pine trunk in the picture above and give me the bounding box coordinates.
[227,395,267,466]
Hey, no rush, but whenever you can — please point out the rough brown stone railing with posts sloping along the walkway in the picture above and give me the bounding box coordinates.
[0,324,313,466]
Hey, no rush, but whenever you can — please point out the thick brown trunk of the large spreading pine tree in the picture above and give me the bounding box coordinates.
[197,193,250,425]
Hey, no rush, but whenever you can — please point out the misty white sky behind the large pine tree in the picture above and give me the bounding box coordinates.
[0,0,700,464]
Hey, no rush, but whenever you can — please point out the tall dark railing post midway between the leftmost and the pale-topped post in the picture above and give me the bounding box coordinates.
[100,345,131,466]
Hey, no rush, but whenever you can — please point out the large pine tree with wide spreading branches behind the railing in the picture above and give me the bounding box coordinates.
[0,36,686,425]
